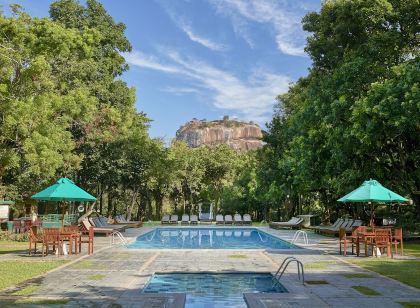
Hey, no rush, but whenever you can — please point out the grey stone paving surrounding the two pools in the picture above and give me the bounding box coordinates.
[0,227,420,308]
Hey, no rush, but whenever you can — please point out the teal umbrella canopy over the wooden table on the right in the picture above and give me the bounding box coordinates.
[337,180,408,203]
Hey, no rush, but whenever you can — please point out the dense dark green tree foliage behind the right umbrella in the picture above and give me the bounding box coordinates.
[259,0,420,223]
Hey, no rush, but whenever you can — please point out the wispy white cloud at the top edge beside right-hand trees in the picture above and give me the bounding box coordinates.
[209,0,306,56]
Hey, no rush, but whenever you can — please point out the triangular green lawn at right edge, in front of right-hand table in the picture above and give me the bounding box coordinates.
[350,258,420,288]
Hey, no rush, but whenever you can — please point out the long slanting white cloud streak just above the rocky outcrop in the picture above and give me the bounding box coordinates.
[125,50,291,123]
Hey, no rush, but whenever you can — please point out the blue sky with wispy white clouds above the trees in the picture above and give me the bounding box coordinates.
[0,0,320,140]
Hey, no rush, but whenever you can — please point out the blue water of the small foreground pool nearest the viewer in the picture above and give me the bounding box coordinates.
[143,273,287,308]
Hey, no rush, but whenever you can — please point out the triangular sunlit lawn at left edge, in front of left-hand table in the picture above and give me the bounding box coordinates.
[0,260,66,290]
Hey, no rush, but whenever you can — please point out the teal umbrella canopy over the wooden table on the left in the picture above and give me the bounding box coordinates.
[31,178,96,201]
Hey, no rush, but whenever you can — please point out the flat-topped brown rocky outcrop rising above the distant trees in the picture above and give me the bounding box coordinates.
[176,116,262,151]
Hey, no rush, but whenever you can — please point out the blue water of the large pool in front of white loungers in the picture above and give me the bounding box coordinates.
[128,227,298,249]
